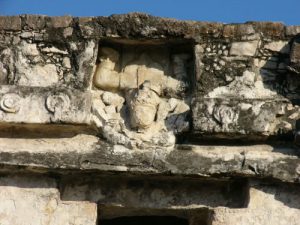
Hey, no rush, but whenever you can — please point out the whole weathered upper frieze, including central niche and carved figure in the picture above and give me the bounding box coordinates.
[0,14,300,165]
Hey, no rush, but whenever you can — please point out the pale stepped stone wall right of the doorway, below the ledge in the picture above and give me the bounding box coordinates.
[212,182,300,225]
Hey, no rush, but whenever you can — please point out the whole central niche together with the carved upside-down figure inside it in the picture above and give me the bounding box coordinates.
[92,39,195,149]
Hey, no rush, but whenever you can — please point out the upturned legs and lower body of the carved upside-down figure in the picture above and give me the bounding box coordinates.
[94,47,188,93]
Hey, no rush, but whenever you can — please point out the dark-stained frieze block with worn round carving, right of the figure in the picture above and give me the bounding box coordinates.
[192,98,299,139]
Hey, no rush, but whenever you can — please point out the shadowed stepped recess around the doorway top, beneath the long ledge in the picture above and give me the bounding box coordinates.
[60,175,248,225]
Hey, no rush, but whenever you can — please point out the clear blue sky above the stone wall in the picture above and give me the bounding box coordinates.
[0,0,300,25]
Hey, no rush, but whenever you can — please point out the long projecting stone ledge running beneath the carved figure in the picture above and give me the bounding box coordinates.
[0,142,300,183]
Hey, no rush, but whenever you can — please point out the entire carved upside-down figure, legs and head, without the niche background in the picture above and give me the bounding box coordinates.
[93,47,189,149]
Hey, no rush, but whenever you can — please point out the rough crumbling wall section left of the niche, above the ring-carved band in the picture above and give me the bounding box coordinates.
[0,37,97,89]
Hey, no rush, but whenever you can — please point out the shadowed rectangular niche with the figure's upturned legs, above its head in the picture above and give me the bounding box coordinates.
[93,40,194,97]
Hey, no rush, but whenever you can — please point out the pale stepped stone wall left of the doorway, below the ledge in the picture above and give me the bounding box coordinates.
[0,176,97,225]
